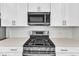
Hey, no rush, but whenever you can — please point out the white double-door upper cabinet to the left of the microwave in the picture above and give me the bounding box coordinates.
[1,3,27,26]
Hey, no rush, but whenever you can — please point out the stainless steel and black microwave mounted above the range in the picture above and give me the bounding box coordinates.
[28,12,50,26]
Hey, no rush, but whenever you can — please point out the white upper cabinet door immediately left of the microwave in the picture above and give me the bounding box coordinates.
[16,3,27,26]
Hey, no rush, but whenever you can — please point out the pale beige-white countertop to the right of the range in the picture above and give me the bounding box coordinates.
[51,38,79,47]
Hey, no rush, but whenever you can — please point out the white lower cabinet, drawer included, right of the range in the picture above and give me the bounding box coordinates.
[56,47,79,56]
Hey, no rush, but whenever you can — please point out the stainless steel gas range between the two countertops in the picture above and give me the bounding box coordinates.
[23,31,56,56]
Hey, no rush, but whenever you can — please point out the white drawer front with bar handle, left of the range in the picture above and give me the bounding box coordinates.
[2,47,23,52]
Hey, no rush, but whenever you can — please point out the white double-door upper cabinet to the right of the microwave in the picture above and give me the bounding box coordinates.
[51,3,79,26]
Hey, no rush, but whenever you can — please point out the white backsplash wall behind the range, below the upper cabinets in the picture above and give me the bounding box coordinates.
[6,26,72,38]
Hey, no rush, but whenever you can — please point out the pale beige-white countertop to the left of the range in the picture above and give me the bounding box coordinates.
[0,38,27,47]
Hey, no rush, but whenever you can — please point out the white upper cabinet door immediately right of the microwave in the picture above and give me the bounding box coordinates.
[51,3,67,26]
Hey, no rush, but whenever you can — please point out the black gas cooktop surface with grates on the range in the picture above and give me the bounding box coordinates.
[24,35,55,47]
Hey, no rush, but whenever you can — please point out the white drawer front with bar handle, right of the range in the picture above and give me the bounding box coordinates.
[56,47,79,52]
